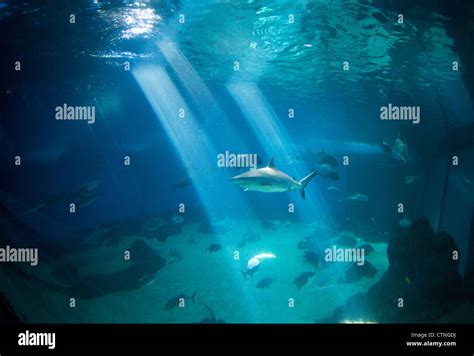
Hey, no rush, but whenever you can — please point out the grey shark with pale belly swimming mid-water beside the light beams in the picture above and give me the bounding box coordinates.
[230,157,318,199]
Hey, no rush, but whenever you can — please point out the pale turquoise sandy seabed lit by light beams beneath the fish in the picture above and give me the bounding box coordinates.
[2,219,388,323]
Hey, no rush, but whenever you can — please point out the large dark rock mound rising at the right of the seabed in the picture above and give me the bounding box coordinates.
[333,218,466,323]
